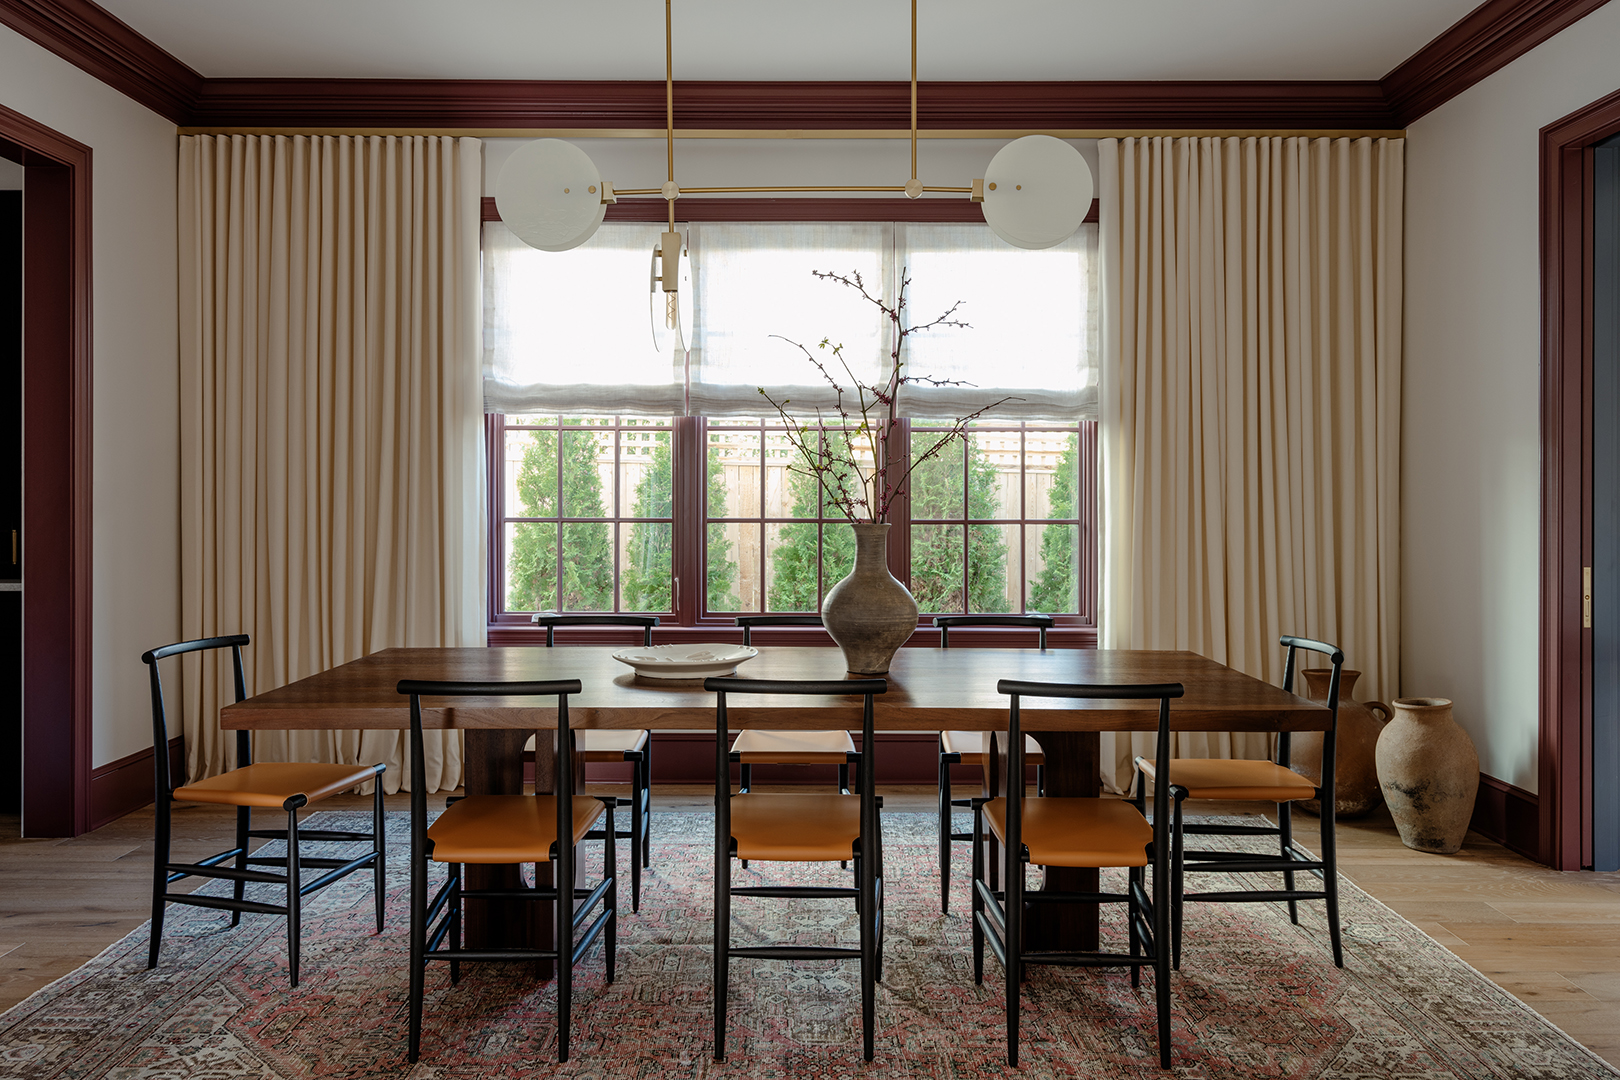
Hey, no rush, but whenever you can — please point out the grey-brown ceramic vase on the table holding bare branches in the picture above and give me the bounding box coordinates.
[821,521,917,675]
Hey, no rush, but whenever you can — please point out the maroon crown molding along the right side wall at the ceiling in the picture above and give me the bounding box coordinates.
[1382,0,1609,128]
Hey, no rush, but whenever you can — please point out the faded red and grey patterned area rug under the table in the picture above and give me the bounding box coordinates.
[0,813,1620,1080]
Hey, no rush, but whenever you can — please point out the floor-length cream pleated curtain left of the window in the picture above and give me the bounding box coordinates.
[180,136,486,792]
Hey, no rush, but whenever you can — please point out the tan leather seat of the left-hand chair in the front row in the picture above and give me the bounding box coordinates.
[428,795,604,863]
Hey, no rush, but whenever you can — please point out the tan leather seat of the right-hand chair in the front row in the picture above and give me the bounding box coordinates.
[985,798,1153,868]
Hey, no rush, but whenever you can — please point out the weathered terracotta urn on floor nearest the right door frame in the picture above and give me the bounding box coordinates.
[1379,698,1479,855]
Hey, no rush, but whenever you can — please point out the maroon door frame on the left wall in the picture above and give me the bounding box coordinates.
[0,105,91,837]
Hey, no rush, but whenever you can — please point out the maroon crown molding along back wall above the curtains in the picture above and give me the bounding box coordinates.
[190,79,1398,131]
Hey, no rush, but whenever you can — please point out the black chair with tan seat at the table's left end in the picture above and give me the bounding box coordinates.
[141,633,387,986]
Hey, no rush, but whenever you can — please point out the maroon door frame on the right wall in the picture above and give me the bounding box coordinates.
[1537,91,1620,870]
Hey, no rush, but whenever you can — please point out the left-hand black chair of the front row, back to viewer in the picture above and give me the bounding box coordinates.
[399,678,619,1062]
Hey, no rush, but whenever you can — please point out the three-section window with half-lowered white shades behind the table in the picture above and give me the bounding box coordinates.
[484,222,1095,625]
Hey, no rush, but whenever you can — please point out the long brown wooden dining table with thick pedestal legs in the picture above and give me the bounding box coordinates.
[220,644,1332,949]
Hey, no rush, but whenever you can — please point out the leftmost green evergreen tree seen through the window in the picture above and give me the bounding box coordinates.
[505,429,612,612]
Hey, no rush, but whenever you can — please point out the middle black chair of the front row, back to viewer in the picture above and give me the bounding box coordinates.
[703,678,888,1061]
